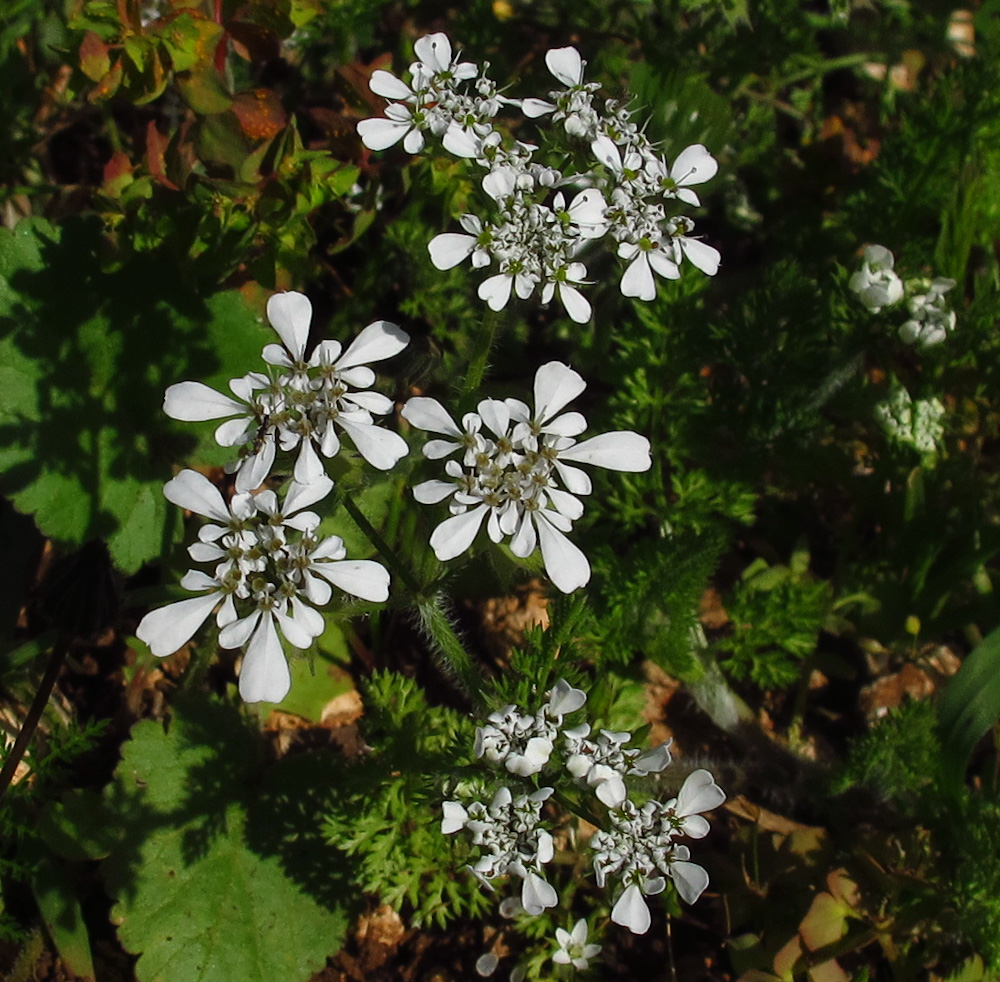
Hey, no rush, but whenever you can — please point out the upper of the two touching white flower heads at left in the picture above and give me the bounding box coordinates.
[163,292,409,492]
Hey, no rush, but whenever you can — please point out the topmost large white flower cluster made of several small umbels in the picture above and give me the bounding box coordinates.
[358,34,720,323]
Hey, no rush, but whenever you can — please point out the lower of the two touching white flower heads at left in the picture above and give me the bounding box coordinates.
[136,470,389,702]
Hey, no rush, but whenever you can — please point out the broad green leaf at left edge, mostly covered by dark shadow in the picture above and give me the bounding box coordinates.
[0,219,265,573]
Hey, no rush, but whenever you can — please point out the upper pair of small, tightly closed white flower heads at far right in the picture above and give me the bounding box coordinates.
[848,245,956,348]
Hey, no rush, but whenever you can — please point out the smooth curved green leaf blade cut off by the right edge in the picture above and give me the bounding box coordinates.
[937,628,1000,791]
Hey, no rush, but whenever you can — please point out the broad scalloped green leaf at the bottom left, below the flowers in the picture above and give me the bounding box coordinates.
[102,698,346,982]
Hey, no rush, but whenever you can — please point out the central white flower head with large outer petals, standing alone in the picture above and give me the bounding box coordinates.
[402,361,651,593]
